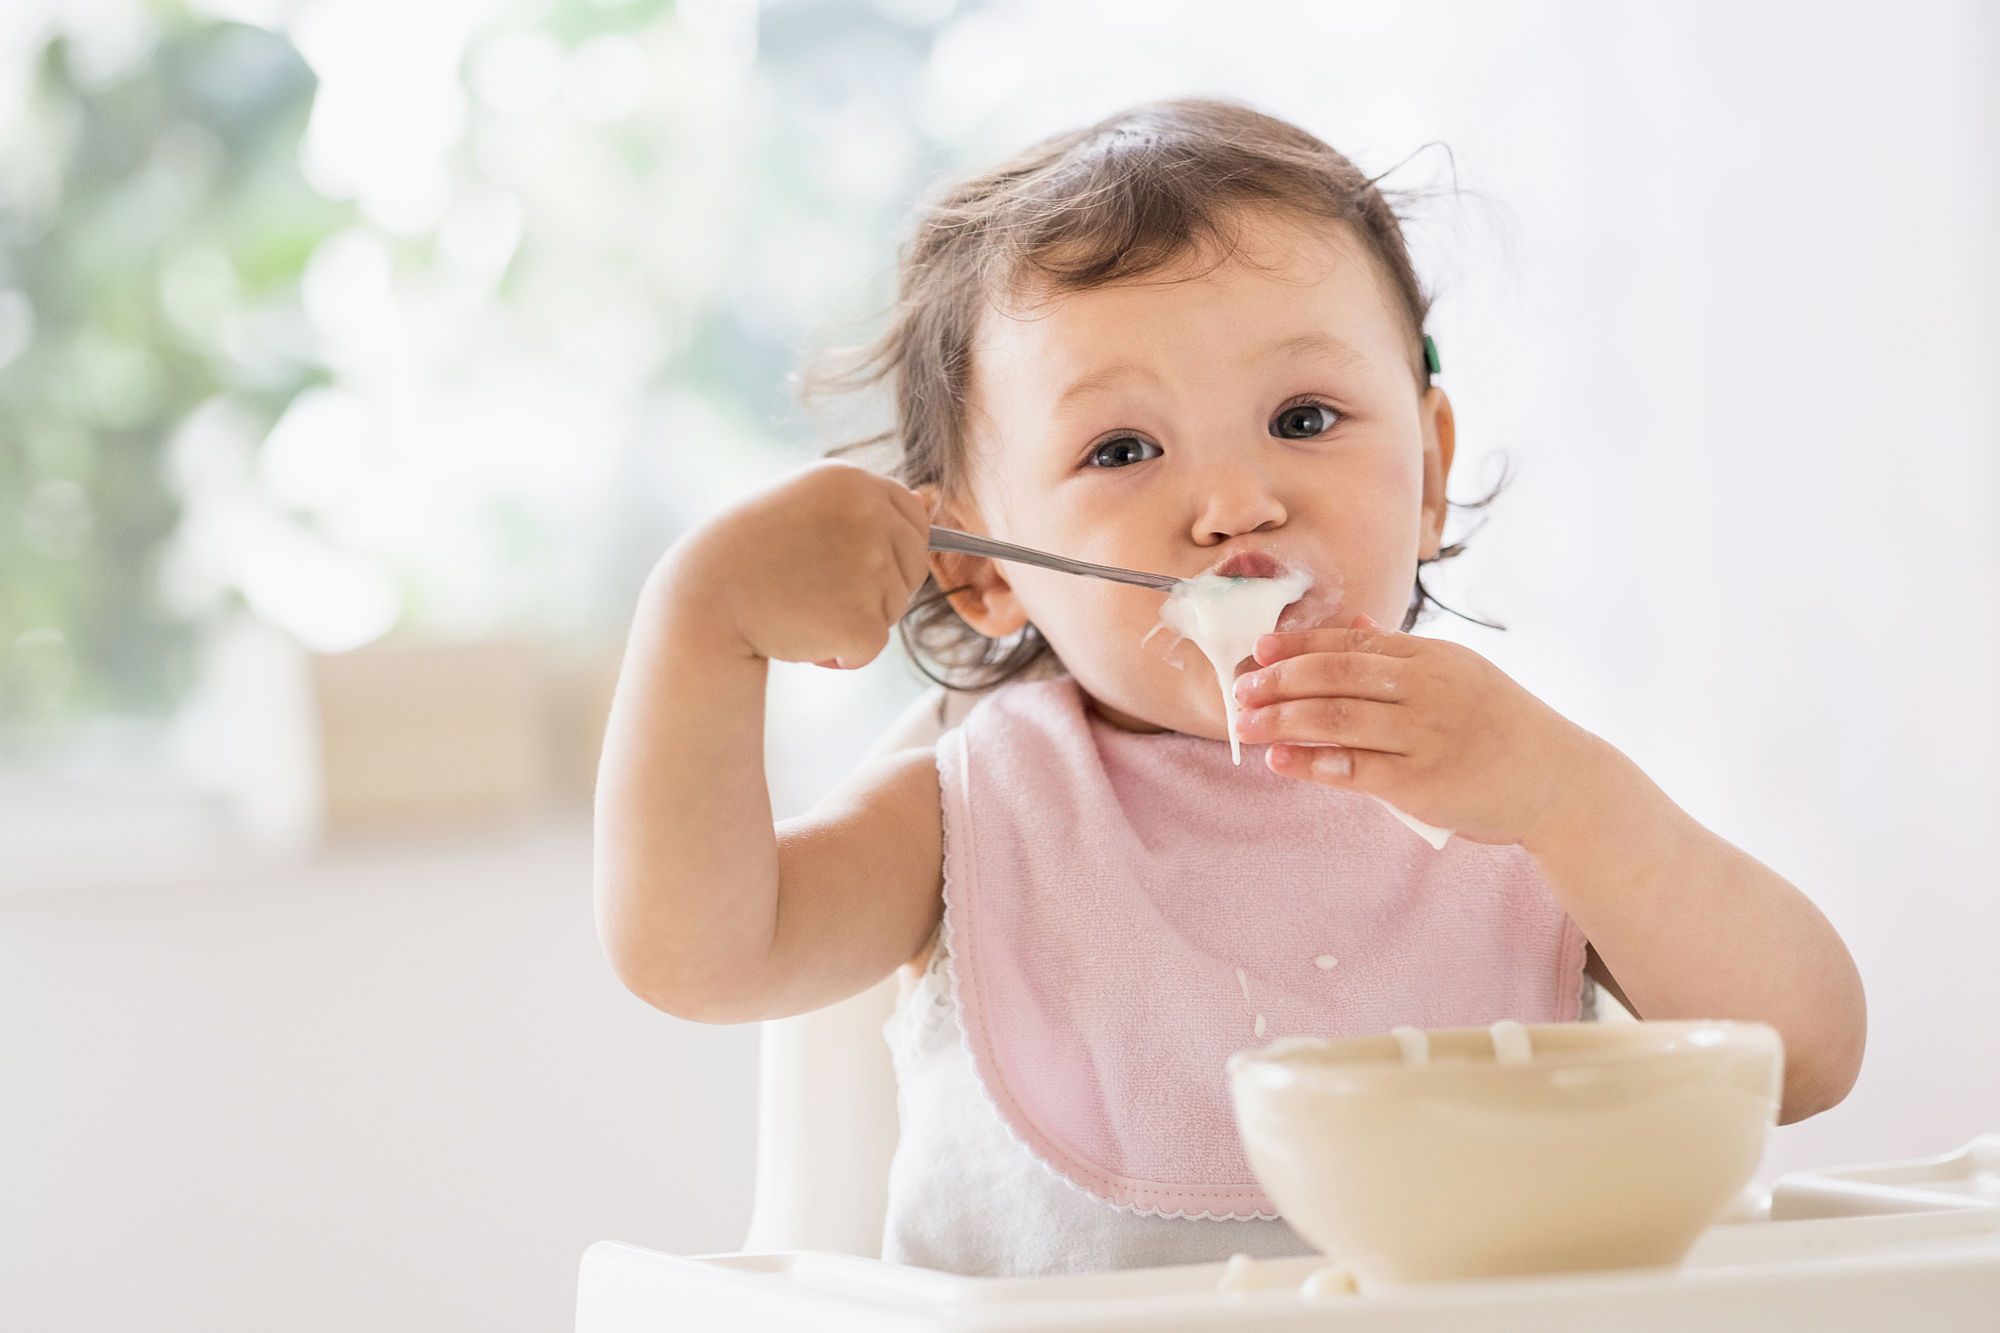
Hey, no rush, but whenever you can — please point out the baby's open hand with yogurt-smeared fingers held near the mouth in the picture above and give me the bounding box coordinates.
[1236,616,1602,843]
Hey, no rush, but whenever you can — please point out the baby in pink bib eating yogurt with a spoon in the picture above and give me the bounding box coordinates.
[596,100,1866,1275]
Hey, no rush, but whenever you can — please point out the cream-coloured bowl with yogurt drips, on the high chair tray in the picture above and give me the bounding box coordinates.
[1228,1021,1784,1287]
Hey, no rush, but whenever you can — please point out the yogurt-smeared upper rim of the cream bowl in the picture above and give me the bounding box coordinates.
[1228,1019,1784,1083]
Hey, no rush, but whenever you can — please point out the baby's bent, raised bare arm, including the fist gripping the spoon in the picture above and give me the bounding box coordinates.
[596,464,940,1023]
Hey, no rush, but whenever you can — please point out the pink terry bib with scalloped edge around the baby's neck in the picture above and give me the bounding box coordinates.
[938,677,1584,1219]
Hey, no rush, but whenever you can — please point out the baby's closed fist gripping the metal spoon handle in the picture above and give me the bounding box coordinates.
[666,460,930,667]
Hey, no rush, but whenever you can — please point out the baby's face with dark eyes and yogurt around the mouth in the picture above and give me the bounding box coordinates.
[940,216,1452,739]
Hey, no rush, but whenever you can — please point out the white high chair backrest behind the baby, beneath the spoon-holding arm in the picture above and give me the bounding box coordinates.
[744,689,978,1257]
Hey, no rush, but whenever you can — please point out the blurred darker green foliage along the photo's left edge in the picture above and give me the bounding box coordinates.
[0,14,352,723]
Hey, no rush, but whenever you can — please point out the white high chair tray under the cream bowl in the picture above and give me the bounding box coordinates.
[576,1135,2000,1333]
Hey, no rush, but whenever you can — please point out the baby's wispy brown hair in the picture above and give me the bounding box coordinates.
[802,98,1506,691]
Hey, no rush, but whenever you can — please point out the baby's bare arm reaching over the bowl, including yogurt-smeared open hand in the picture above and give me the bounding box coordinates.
[1236,614,1868,1123]
